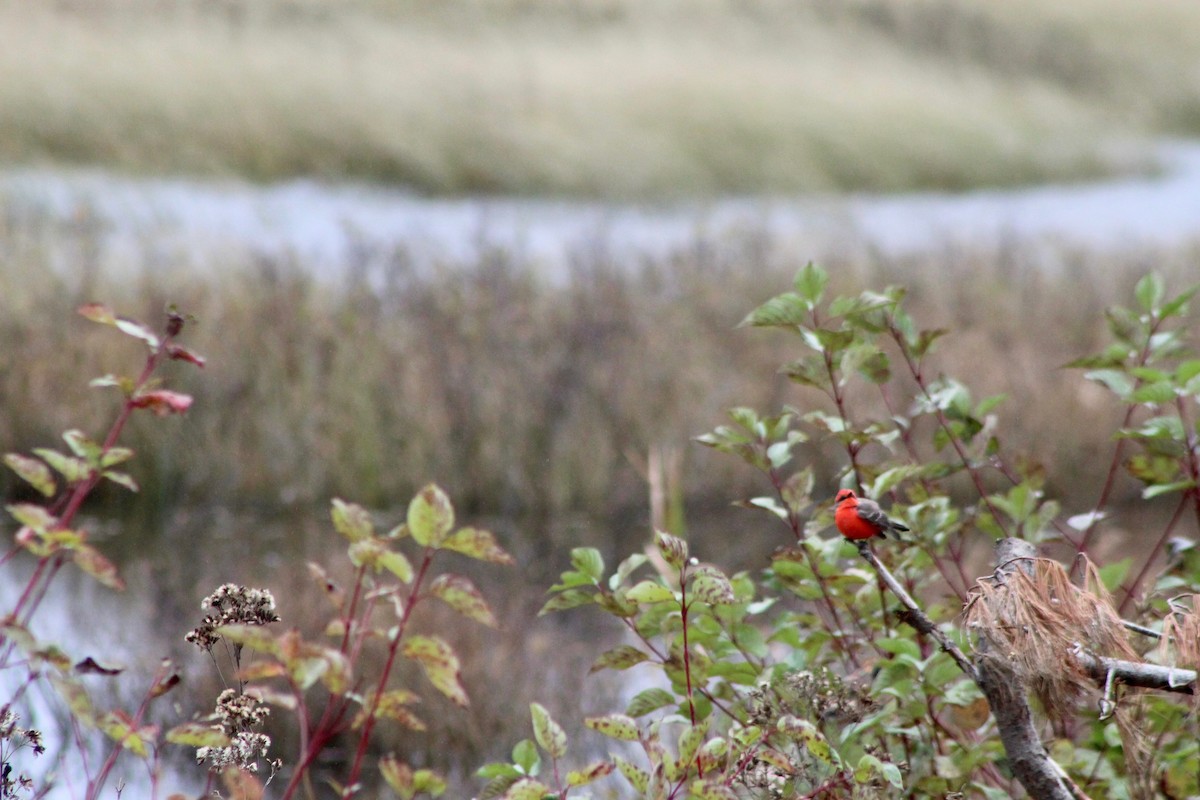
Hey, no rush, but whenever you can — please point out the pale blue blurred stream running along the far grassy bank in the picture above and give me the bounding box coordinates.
[7,143,1200,277]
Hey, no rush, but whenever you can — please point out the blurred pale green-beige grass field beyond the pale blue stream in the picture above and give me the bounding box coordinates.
[0,0,1200,198]
